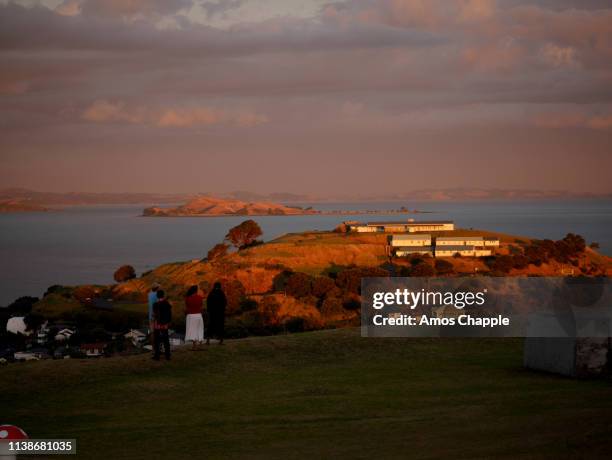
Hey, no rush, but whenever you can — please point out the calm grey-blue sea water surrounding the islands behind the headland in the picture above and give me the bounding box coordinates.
[0,201,612,305]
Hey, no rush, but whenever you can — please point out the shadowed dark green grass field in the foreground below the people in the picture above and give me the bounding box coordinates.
[0,329,612,459]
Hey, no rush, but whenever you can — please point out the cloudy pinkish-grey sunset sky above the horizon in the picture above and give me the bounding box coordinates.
[0,0,612,195]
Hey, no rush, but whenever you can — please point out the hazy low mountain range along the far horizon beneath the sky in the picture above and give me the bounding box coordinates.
[0,188,612,212]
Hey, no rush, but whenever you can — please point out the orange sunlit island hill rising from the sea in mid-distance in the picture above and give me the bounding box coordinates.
[143,196,318,217]
